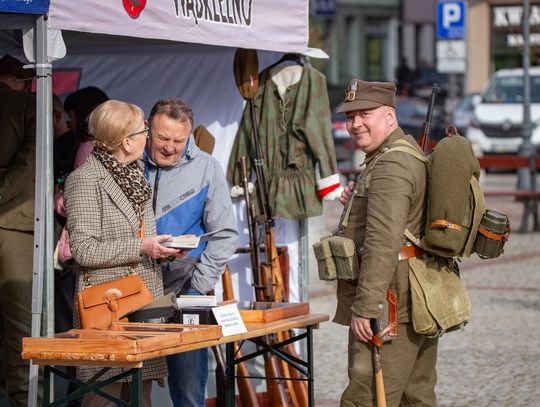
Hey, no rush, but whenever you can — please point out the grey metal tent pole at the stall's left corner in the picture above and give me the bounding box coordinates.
[28,15,54,407]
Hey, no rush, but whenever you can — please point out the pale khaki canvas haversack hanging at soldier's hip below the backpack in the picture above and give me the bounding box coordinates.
[409,256,471,337]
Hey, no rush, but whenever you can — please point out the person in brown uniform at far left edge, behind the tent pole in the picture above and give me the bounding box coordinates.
[0,55,41,407]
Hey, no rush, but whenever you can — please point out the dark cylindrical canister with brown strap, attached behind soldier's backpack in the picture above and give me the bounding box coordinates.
[474,209,510,259]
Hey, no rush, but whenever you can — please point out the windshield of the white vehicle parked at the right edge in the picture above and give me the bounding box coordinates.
[484,76,540,103]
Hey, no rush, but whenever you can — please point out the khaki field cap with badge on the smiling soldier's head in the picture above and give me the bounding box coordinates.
[337,79,396,113]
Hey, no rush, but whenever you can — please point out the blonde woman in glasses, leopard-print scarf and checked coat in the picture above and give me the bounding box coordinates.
[64,100,185,407]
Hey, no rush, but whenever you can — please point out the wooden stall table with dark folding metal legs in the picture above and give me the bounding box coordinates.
[22,314,329,407]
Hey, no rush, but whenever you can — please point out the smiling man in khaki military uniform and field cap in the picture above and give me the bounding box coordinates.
[334,79,437,407]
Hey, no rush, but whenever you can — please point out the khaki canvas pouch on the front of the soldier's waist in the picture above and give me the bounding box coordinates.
[313,234,359,281]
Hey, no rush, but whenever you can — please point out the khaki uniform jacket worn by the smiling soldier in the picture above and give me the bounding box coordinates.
[334,128,427,325]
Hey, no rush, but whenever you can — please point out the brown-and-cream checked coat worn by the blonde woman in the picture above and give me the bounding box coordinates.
[64,155,167,380]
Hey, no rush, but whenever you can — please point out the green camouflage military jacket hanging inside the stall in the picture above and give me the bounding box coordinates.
[227,65,337,219]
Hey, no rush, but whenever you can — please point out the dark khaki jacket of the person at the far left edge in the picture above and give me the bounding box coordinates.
[0,83,36,232]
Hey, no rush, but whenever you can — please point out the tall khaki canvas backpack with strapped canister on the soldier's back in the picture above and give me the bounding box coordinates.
[422,134,510,258]
